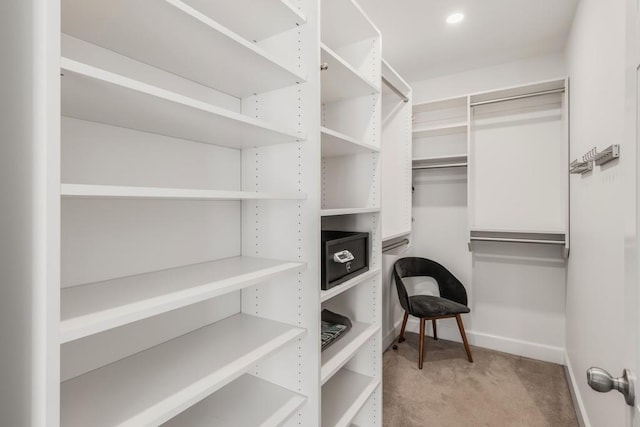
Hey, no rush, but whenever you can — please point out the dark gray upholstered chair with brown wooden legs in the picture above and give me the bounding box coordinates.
[393,257,473,369]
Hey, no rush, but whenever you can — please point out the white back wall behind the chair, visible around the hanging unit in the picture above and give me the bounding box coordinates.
[383,55,566,363]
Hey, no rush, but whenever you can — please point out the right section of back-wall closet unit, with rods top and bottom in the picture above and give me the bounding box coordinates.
[468,79,569,252]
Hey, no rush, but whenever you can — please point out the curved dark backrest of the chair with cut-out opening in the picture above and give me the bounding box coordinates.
[393,257,467,311]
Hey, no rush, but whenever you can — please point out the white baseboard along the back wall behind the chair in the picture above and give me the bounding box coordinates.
[384,317,565,365]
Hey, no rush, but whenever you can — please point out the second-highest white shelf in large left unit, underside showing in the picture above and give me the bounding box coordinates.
[62,0,305,98]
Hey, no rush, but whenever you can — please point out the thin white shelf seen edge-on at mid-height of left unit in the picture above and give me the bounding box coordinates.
[60,184,307,201]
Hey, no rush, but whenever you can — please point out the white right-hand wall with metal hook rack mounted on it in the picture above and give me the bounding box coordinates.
[566,0,631,426]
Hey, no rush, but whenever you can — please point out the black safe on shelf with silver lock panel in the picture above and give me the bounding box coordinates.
[320,230,369,290]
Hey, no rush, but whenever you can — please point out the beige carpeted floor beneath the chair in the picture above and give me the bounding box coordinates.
[383,333,578,427]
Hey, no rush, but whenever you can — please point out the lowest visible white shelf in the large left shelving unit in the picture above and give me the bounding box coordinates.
[162,374,307,427]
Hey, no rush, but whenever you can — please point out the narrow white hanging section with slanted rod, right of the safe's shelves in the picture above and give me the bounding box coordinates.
[381,60,412,242]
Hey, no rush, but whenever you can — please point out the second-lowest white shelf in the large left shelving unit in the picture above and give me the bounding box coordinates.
[60,314,305,427]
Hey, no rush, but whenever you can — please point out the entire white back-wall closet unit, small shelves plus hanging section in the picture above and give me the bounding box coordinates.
[412,79,569,252]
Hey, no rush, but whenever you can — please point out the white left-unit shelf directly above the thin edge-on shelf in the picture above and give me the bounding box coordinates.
[61,59,306,148]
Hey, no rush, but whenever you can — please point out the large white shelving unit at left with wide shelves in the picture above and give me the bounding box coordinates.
[58,0,320,427]
